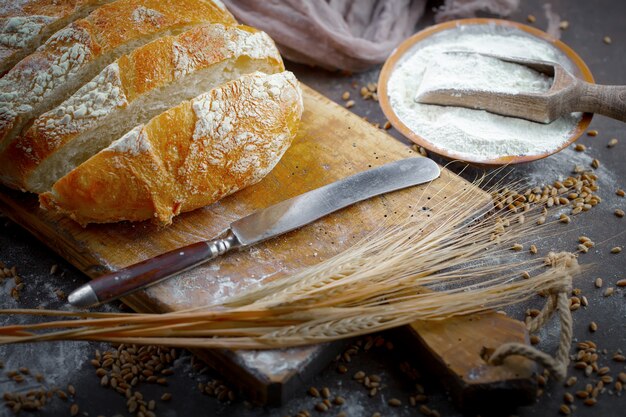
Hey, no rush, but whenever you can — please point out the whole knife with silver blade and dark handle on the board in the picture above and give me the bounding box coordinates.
[68,158,440,307]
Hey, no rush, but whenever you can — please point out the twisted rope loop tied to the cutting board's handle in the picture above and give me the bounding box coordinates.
[489,280,573,380]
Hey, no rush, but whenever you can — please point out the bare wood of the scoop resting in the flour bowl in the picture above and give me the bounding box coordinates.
[415,52,626,123]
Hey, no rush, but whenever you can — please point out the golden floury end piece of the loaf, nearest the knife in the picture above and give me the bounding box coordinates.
[40,72,303,225]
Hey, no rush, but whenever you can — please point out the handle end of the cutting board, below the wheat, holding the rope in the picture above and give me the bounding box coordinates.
[403,312,537,415]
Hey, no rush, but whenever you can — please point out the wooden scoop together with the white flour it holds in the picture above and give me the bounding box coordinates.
[415,51,626,123]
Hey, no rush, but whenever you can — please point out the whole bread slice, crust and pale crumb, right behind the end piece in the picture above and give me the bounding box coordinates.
[0,24,284,193]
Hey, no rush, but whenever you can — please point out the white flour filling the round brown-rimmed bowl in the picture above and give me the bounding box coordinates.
[388,26,581,161]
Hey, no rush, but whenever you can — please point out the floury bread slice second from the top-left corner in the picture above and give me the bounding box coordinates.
[0,0,236,151]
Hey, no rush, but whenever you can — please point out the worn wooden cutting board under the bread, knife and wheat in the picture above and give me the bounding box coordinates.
[0,86,532,404]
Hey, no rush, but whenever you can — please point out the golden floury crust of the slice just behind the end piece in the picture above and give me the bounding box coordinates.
[0,24,284,192]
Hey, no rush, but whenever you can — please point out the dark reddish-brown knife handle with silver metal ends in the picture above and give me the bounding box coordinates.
[68,230,239,307]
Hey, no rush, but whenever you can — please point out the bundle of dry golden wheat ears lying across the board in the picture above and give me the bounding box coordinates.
[0,171,579,349]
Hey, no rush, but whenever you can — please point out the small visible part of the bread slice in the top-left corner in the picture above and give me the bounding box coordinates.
[0,0,113,75]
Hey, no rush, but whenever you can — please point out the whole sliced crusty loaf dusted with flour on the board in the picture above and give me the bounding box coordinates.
[0,0,303,225]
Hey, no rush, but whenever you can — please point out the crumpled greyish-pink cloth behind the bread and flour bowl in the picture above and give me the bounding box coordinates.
[224,0,519,71]
